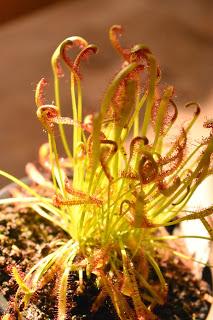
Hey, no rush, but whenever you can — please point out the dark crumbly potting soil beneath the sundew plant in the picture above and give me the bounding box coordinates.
[0,207,209,320]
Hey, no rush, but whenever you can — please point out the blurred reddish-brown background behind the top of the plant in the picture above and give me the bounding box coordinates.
[0,0,213,185]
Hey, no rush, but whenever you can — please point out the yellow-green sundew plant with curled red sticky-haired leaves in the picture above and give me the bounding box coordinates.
[1,25,213,320]
